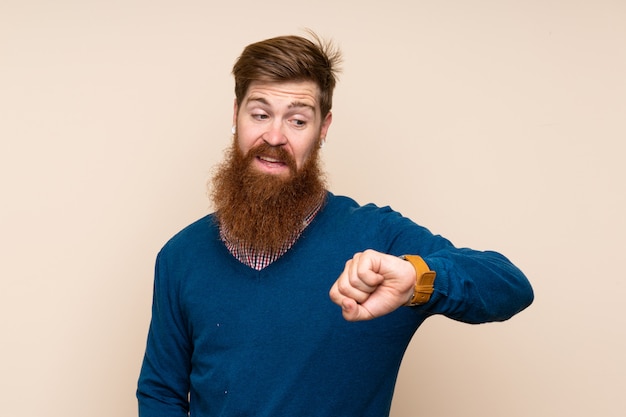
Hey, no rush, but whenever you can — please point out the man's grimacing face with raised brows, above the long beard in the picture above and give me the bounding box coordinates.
[233,81,332,177]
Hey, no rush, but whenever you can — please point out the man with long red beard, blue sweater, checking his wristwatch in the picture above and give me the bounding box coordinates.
[137,35,533,417]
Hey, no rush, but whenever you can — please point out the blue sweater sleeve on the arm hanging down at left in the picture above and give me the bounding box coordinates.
[137,252,192,417]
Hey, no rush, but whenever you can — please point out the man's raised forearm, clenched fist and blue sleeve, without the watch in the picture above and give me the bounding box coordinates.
[330,244,534,323]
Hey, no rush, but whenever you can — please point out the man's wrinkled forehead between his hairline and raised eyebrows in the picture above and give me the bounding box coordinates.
[242,81,320,110]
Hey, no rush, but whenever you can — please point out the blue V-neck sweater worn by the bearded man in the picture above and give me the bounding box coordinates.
[137,193,533,417]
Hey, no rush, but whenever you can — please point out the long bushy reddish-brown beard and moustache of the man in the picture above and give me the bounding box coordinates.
[211,138,326,253]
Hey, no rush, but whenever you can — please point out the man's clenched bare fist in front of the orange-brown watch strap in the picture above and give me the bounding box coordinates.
[330,249,416,321]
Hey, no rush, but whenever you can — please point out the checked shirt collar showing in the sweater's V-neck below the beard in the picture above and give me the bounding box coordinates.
[220,201,323,271]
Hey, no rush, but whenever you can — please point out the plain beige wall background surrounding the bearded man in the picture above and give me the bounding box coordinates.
[0,0,626,417]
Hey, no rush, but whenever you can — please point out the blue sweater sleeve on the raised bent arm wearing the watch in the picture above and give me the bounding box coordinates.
[382,213,534,323]
